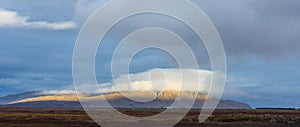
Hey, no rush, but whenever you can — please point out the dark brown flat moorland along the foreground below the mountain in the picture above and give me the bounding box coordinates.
[0,108,300,127]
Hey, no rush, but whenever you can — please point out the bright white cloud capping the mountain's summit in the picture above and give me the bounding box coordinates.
[97,69,213,93]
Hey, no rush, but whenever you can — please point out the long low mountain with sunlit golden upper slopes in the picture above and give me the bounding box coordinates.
[6,91,251,109]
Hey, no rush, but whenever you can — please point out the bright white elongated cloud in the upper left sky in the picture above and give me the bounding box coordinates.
[0,8,76,30]
